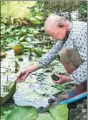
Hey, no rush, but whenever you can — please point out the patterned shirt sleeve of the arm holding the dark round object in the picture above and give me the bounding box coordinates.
[70,22,87,84]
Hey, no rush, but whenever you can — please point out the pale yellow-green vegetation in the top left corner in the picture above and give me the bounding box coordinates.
[1,1,36,18]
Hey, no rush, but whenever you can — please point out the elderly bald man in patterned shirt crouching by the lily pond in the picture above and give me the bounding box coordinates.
[17,14,87,99]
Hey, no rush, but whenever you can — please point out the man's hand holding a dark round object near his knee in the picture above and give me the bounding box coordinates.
[54,74,71,84]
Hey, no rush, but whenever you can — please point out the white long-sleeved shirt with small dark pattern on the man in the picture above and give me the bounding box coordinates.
[38,21,87,84]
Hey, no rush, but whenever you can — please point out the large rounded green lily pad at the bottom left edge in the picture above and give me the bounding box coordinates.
[6,107,37,120]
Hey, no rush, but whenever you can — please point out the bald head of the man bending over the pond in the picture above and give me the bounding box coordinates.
[44,14,72,40]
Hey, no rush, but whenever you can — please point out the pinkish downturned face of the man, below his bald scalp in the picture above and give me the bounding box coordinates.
[45,25,67,40]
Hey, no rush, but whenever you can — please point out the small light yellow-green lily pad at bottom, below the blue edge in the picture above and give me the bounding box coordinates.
[49,104,68,120]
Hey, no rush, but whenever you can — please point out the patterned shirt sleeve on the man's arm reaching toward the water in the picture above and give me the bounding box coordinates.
[38,41,62,68]
